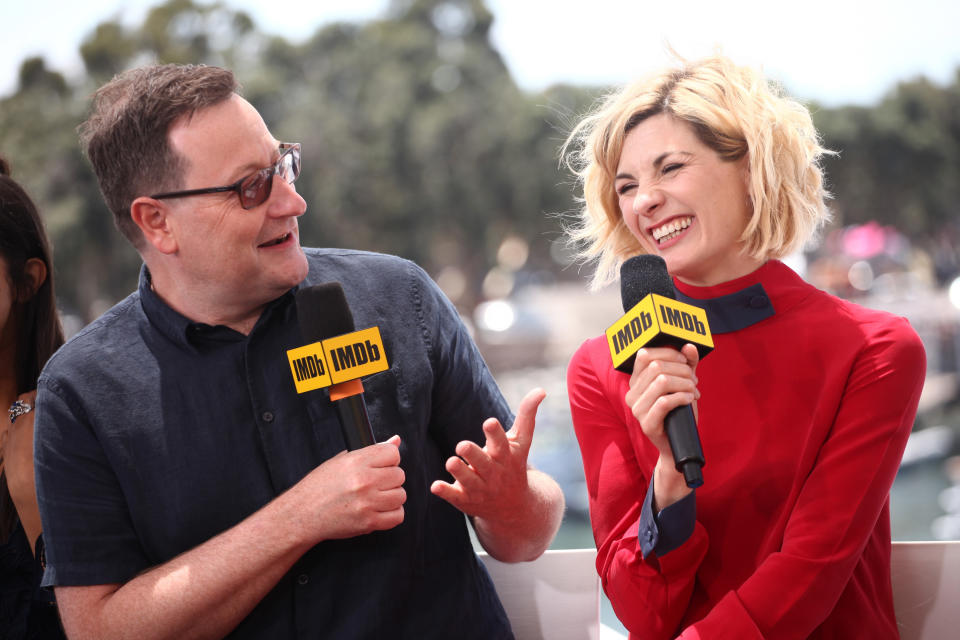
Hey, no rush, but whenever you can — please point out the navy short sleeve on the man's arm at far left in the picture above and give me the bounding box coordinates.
[34,376,150,587]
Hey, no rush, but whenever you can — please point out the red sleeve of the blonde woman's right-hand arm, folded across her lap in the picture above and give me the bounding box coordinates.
[681,317,926,640]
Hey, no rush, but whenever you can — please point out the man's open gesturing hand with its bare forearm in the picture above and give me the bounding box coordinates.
[430,389,564,562]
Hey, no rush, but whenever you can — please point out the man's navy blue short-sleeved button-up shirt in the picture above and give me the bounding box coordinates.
[36,249,513,638]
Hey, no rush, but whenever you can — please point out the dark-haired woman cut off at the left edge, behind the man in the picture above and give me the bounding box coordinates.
[0,158,64,639]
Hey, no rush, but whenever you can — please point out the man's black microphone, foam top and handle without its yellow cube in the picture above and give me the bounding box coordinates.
[295,282,380,451]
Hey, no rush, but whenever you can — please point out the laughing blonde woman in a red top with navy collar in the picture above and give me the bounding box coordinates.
[564,56,925,639]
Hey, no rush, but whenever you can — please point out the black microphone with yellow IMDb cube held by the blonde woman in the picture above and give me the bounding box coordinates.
[607,254,713,488]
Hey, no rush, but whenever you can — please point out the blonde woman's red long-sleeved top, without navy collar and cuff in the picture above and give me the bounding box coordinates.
[567,261,926,640]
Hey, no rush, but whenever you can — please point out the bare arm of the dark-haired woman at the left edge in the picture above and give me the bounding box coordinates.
[0,390,42,551]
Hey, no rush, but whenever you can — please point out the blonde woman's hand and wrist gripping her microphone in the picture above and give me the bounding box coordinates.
[624,344,700,510]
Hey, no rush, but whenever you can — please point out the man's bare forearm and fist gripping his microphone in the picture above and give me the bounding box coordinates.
[56,436,406,640]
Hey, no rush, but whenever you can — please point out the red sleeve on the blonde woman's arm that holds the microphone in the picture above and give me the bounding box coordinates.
[567,341,708,639]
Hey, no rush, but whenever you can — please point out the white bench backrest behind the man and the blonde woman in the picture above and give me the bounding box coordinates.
[480,541,960,640]
